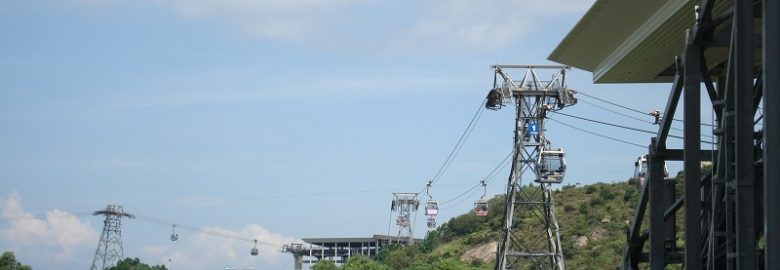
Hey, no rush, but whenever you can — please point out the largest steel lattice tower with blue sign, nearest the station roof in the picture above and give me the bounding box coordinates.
[485,65,576,270]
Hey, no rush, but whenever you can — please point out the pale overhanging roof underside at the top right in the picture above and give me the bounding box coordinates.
[548,0,699,83]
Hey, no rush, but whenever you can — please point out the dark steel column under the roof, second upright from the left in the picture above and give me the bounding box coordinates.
[683,30,702,269]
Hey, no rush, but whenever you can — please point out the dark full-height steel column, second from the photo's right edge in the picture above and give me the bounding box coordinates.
[734,0,757,270]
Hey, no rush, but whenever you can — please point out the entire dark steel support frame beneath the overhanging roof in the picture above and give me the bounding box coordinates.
[621,0,780,270]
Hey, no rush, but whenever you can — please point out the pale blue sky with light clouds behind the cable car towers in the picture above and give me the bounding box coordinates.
[0,0,710,269]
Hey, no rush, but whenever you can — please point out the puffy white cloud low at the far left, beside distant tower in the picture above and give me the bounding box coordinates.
[0,192,98,260]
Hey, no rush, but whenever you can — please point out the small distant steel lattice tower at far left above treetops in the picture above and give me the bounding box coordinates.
[90,204,135,270]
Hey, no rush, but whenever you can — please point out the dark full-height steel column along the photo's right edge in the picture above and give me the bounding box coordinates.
[762,0,780,269]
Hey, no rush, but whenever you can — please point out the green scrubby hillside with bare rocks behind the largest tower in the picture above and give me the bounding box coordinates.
[317,180,639,270]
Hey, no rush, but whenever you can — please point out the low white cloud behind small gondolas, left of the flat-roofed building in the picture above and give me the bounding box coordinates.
[142,224,301,269]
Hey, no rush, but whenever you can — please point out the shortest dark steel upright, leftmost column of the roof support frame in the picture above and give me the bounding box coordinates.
[647,152,674,270]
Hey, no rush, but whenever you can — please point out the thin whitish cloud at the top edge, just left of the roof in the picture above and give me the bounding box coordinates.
[391,0,593,51]
